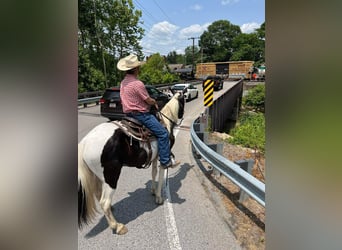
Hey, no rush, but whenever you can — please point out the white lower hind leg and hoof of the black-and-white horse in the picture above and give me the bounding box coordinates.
[100,183,128,234]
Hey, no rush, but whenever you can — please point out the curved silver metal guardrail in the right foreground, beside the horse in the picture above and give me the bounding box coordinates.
[190,118,265,207]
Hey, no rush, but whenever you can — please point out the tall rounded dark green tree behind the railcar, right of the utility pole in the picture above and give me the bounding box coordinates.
[200,20,241,62]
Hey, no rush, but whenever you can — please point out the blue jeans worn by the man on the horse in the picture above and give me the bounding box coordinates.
[129,113,171,165]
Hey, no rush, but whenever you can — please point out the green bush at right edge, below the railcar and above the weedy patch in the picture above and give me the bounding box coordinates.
[242,84,265,112]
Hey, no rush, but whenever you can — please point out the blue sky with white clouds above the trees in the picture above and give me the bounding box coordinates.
[133,0,265,56]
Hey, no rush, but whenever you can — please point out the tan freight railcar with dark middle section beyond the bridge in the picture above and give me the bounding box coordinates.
[195,61,254,79]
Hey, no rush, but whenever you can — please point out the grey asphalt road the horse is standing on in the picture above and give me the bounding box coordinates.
[78,82,240,250]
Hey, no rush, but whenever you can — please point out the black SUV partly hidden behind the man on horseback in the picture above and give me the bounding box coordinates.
[99,85,171,121]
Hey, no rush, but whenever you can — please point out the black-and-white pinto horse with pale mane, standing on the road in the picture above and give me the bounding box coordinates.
[78,93,184,235]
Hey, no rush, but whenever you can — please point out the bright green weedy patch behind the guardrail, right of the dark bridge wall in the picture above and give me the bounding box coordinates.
[228,112,265,153]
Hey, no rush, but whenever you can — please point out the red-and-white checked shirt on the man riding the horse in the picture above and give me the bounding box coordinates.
[120,74,150,113]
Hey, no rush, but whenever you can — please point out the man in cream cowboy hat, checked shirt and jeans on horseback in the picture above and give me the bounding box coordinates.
[117,54,180,168]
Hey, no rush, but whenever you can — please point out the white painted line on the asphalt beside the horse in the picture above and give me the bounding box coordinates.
[164,129,182,250]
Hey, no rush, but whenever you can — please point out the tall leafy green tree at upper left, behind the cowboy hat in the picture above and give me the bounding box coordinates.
[78,0,144,91]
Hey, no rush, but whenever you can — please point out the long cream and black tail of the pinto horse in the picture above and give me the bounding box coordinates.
[78,144,101,228]
